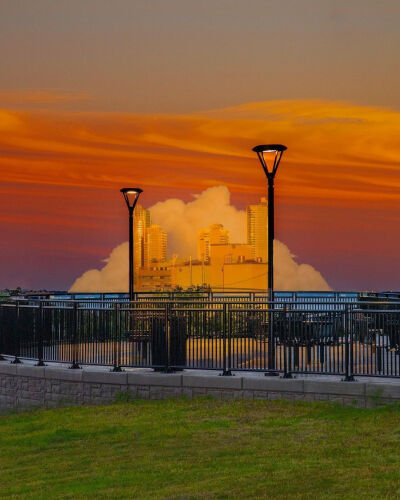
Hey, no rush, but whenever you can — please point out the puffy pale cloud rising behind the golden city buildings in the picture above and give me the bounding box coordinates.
[70,186,330,292]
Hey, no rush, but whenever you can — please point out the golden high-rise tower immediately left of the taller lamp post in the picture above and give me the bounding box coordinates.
[247,198,268,262]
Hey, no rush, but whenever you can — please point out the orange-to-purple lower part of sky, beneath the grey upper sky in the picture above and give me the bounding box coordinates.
[0,96,400,289]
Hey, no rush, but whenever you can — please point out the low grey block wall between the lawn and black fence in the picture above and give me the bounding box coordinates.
[0,362,400,411]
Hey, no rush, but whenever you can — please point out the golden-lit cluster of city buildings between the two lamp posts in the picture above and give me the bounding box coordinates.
[135,203,268,292]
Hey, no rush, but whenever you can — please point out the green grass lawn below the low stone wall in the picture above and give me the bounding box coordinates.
[0,398,400,499]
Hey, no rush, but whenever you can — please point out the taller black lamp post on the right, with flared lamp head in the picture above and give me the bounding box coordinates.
[253,144,287,375]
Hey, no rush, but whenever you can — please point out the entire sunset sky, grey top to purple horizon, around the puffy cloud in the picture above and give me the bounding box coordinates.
[0,0,400,290]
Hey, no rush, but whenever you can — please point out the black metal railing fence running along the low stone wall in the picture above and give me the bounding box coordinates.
[0,300,400,380]
